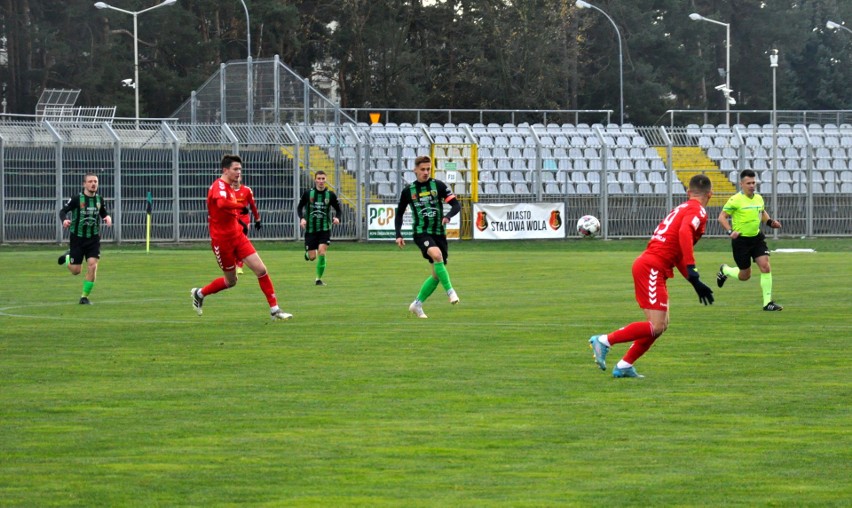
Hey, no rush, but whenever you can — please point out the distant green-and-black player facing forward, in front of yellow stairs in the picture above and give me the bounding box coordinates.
[296,171,342,286]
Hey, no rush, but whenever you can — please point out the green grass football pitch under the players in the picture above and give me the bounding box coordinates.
[0,240,852,507]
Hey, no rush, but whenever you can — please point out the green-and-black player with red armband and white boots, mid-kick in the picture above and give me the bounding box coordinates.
[394,155,461,318]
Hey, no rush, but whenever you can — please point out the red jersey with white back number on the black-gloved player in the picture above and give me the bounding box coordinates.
[645,199,707,273]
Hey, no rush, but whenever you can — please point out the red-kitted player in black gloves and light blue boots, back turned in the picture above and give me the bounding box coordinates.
[589,175,713,378]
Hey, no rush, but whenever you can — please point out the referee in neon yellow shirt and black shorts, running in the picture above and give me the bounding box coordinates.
[716,169,784,311]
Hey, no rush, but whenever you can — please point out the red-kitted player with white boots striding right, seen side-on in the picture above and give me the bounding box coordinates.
[192,155,293,320]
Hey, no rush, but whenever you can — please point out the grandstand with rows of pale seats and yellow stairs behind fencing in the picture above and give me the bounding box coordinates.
[0,59,852,243]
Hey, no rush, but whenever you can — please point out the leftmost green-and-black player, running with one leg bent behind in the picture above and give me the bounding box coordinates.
[58,173,112,305]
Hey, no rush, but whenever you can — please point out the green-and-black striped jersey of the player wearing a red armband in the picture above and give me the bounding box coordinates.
[394,178,461,238]
